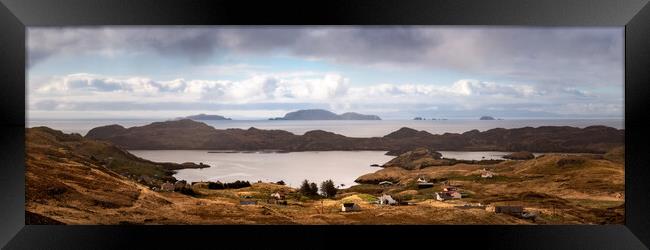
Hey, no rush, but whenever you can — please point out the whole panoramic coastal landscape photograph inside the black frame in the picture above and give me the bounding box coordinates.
[25,26,625,225]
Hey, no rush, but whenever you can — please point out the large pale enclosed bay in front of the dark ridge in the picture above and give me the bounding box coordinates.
[129,150,393,187]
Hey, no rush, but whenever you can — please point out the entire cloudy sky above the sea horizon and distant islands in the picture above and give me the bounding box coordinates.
[27,26,624,119]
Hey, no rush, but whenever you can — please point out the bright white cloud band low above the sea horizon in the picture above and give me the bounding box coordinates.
[28,72,622,118]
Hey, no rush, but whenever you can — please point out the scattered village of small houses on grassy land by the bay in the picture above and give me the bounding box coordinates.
[152,168,541,223]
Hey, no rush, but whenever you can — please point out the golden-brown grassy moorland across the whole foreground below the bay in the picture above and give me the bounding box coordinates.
[25,127,625,225]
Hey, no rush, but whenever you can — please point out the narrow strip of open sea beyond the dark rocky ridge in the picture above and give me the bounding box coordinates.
[27,119,624,137]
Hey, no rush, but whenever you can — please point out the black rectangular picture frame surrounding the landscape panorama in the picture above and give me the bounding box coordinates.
[0,0,650,249]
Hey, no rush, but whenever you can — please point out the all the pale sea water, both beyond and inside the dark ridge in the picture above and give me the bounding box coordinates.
[27,119,624,187]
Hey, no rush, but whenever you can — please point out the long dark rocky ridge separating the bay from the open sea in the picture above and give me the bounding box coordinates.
[86,120,625,155]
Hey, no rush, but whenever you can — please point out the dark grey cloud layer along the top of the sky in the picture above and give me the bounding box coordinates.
[29,26,623,85]
